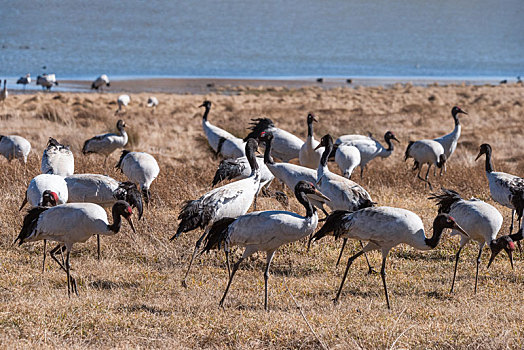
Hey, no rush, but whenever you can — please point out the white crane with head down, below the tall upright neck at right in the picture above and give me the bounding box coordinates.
[404,140,446,190]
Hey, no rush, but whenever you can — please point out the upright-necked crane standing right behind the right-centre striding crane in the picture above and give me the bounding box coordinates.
[316,134,375,273]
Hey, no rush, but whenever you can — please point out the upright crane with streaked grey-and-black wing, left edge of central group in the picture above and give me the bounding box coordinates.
[171,139,260,286]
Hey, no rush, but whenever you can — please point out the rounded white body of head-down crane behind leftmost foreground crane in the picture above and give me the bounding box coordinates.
[26,174,69,207]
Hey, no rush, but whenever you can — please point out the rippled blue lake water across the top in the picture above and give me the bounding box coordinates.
[0,0,524,79]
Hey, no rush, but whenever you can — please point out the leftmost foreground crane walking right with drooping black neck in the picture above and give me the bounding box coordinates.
[15,201,135,295]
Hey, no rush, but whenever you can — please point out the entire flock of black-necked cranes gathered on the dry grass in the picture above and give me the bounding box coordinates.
[0,93,524,310]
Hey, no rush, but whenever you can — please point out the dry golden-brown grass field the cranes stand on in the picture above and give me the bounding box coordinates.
[0,84,524,349]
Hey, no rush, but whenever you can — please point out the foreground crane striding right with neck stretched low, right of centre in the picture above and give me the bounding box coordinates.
[313,207,468,309]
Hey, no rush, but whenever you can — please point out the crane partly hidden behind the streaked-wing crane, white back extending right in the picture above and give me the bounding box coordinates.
[258,131,329,216]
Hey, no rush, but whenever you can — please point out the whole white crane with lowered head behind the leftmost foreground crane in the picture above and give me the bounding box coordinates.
[19,174,69,272]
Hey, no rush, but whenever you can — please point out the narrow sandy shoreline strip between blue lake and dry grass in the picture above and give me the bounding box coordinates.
[8,77,516,94]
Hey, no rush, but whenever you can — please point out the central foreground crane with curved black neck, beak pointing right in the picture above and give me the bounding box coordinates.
[203,181,329,310]
